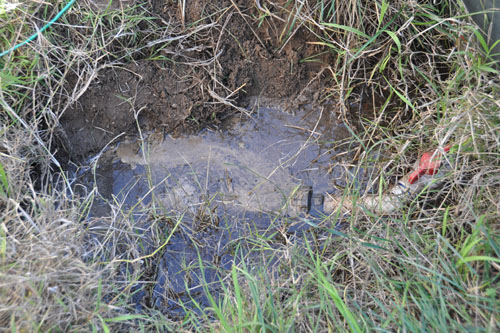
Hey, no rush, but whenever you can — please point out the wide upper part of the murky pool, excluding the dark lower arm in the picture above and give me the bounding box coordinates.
[94,108,340,217]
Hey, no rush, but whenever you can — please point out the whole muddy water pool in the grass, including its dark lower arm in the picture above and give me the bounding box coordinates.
[84,108,354,315]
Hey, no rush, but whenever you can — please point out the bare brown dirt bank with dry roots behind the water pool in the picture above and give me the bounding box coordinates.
[60,0,335,157]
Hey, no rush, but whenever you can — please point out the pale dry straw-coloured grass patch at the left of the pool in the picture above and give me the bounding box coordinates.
[0,126,110,331]
